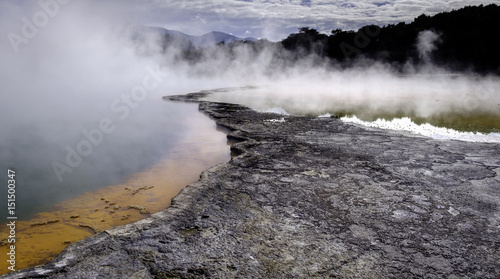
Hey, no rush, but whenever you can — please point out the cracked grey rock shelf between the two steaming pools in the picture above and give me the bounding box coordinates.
[1,92,500,278]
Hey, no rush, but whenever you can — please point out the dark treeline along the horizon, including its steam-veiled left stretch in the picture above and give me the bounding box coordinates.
[159,4,500,75]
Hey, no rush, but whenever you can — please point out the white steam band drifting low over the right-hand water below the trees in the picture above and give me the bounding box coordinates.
[204,66,500,120]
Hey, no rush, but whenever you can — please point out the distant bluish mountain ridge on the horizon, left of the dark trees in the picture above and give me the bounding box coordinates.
[146,27,257,48]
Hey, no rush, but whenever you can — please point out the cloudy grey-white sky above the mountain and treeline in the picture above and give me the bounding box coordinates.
[120,0,500,40]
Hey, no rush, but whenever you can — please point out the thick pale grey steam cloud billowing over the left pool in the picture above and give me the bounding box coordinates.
[0,0,237,219]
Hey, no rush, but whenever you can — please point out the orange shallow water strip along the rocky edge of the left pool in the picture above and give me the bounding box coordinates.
[0,103,230,274]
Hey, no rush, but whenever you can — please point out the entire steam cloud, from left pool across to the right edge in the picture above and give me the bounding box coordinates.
[0,1,500,219]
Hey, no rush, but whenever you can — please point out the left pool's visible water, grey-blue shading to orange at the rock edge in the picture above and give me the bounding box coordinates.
[0,101,230,274]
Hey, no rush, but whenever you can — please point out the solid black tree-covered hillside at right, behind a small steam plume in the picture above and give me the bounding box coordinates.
[281,4,500,74]
